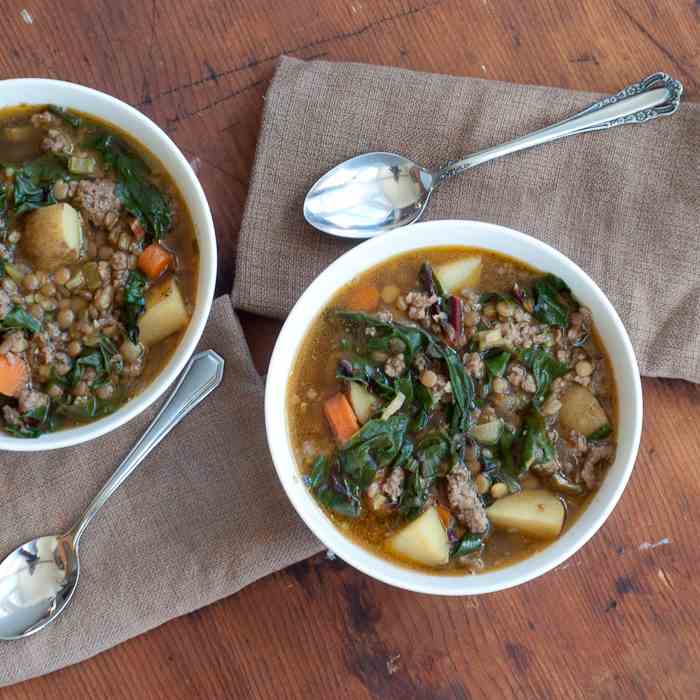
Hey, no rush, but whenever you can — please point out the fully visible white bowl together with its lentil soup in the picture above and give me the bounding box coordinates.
[265,221,642,595]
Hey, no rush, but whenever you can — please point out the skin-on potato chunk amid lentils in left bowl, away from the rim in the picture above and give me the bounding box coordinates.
[22,202,83,272]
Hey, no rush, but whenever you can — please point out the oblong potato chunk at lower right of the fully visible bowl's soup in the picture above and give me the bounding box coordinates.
[486,489,565,540]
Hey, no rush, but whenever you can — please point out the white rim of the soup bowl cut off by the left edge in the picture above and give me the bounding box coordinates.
[0,78,217,452]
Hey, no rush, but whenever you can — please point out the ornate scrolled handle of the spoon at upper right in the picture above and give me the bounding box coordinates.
[434,73,683,186]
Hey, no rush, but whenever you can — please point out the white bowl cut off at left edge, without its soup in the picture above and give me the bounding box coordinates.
[0,78,216,452]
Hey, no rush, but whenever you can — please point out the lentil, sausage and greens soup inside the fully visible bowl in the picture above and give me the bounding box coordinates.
[287,247,616,574]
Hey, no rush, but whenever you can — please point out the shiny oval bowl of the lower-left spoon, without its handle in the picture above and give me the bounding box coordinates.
[0,535,80,640]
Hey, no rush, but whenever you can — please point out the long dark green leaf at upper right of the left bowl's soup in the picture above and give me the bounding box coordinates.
[86,133,172,241]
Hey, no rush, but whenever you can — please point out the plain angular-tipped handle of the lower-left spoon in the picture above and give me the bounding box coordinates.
[69,350,224,549]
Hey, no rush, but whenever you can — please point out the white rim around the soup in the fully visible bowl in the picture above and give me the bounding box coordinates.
[265,219,643,596]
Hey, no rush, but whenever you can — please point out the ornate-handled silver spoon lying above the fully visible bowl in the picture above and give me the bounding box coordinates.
[304,73,683,238]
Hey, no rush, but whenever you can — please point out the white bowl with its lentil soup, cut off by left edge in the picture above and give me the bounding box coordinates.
[0,79,216,451]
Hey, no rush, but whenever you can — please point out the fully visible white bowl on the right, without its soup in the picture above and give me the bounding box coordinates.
[265,221,642,595]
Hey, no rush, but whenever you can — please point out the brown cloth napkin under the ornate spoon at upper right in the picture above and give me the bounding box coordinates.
[234,58,700,382]
